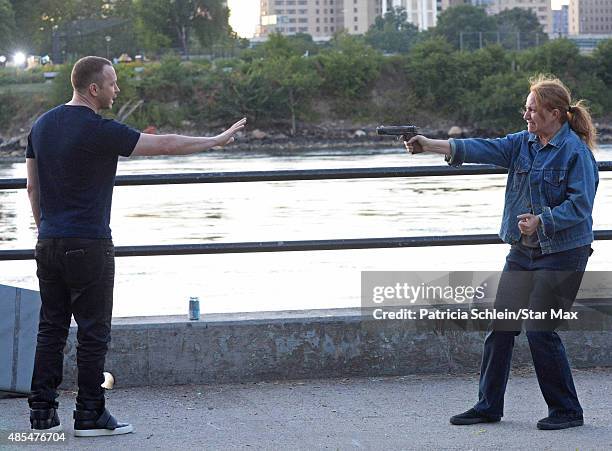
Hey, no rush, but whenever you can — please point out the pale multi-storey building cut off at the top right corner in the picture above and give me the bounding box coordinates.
[568,0,612,35]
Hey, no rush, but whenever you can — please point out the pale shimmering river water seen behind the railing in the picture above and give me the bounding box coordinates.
[0,145,612,316]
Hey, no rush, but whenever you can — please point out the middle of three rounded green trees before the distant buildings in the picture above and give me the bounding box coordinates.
[434,5,497,48]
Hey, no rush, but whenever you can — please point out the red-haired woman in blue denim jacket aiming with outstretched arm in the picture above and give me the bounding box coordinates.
[405,76,599,429]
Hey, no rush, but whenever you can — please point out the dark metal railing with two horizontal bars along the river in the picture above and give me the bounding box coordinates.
[0,161,612,261]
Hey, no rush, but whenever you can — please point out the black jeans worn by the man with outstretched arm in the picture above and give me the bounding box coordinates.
[28,238,115,410]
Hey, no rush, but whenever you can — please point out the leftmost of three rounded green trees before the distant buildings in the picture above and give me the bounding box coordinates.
[365,8,419,53]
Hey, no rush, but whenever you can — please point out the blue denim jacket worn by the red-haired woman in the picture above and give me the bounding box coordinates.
[449,122,599,254]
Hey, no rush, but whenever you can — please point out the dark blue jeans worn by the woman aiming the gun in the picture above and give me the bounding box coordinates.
[474,244,592,418]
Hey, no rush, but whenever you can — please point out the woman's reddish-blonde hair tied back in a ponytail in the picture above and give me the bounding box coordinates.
[529,75,597,149]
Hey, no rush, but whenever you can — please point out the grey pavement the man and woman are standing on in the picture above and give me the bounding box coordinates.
[0,368,612,451]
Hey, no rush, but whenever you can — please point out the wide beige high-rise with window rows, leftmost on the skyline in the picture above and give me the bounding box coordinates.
[256,0,382,40]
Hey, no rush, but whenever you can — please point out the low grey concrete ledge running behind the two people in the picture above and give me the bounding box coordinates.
[56,309,612,388]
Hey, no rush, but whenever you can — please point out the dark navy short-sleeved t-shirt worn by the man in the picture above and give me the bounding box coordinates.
[26,105,140,238]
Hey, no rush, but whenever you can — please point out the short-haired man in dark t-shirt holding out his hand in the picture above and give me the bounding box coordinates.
[26,56,246,436]
